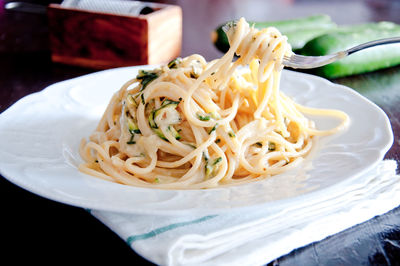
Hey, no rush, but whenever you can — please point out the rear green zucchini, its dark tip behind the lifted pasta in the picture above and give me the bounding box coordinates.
[212,15,337,53]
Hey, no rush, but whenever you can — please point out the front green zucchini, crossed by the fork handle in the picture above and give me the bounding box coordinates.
[298,22,400,79]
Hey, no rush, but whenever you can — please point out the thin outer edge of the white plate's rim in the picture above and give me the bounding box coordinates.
[0,66,394,215]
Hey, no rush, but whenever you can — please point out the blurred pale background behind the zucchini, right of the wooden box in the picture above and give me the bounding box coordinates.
[168,0,400,59]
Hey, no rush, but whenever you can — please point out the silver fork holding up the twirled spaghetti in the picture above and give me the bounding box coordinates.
[283,37,400,69]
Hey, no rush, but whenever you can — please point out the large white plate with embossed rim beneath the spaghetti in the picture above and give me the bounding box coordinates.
[0,67,393,214]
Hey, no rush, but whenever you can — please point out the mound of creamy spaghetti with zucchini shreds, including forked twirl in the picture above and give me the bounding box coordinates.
[80,19,348,189]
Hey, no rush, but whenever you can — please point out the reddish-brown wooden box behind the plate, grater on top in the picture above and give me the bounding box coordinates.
[47,4,182,69]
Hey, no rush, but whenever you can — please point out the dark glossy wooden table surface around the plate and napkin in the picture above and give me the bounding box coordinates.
[0,0,400,265]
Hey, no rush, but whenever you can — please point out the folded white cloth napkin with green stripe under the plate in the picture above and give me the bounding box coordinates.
[91,160,400,265]
